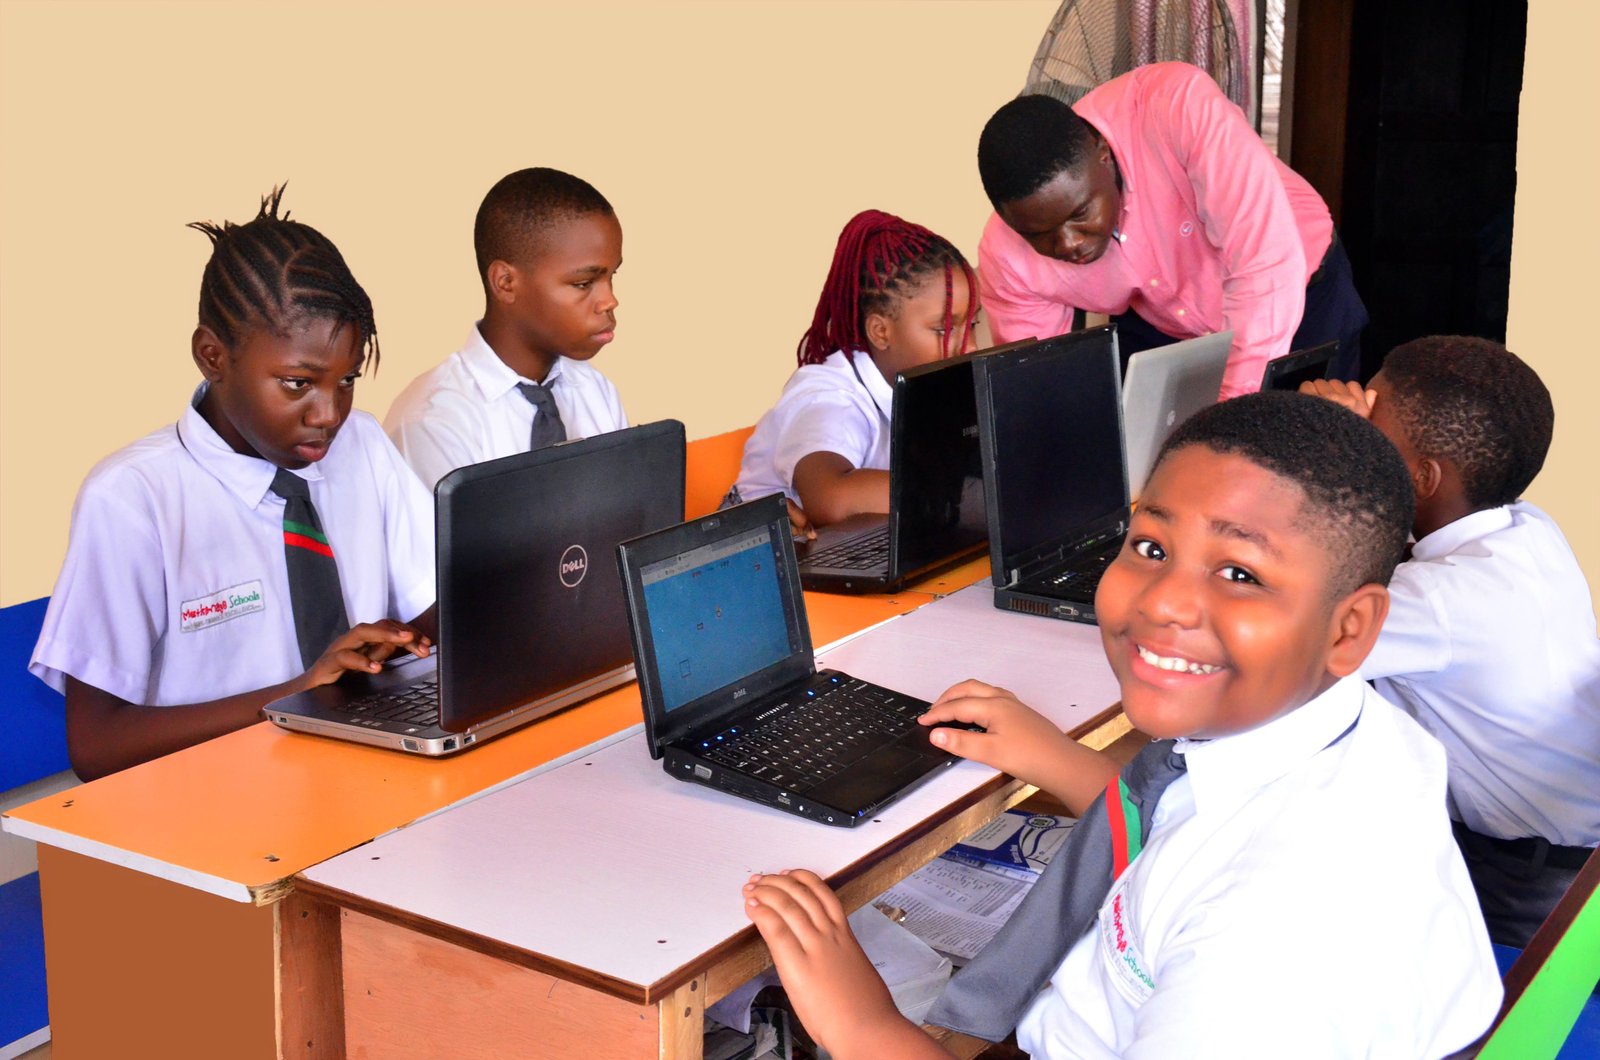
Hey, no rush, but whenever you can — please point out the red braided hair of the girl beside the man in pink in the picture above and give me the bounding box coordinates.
[797,210,978,365]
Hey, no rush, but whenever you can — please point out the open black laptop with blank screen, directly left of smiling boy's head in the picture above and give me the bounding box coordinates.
[974,325,1130,623]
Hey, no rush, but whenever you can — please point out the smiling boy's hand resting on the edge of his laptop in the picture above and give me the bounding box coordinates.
[917,681,1077,789]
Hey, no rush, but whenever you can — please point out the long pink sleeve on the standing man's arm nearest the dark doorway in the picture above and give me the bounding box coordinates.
[1152,70,1307,399]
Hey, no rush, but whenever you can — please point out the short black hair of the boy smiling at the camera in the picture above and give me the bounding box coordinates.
[1155,391,1416,599]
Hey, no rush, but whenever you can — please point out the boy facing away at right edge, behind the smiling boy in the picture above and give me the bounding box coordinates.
[1306,336,1600,946]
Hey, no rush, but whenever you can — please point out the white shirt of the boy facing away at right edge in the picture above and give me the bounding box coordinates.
[1362,501,1600,847]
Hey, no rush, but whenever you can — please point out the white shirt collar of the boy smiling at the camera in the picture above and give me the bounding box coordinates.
[1176,676,1366,813]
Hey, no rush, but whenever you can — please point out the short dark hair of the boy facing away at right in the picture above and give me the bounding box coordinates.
[1382,335,1555,509]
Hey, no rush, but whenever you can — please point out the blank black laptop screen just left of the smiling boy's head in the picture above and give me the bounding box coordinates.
[979,328,1128,567]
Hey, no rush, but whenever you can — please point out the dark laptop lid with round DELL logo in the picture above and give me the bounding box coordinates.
[435,420,685,732]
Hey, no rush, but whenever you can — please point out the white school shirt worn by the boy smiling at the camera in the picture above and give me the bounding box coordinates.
[1016,677,1501,1060]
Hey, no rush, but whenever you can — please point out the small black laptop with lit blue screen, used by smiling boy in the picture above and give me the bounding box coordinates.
[618,495,957,828]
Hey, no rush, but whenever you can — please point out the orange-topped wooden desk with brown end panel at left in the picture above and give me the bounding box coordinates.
[3,592,931,1060]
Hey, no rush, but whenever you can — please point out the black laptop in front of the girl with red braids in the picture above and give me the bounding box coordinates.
[795,347,1032,592]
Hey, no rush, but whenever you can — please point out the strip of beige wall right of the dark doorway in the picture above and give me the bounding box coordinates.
[1506,0,1600,611]
